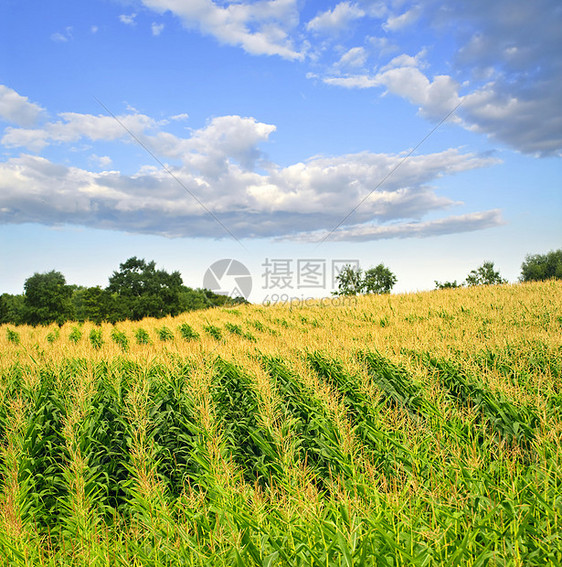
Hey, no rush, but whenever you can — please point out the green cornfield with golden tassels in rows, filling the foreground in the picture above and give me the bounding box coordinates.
[0,281,562,567]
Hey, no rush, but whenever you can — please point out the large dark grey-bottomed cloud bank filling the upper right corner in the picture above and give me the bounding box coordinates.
[309,0,562,156]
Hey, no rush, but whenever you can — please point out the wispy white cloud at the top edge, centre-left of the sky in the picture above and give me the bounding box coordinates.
[138,0,303,60]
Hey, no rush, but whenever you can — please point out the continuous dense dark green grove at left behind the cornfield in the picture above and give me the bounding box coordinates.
[0,256,247,325]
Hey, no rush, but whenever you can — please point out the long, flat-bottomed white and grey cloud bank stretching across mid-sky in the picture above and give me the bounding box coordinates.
[0,104,496,238]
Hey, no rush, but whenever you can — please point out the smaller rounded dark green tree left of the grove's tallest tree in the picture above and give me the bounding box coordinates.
[23,270,73,325]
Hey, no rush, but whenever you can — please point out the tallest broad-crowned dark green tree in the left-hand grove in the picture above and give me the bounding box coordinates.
[106,256,184,320]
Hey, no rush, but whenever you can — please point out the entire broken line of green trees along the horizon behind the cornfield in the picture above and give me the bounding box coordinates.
[0,249,562,325]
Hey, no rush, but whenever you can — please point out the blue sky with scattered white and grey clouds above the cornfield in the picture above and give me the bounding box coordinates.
[0,0,562,301]
